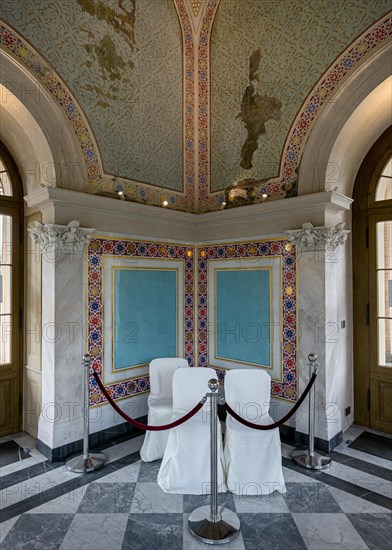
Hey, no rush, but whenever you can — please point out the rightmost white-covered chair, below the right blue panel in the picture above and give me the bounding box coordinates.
[224,369,286,496]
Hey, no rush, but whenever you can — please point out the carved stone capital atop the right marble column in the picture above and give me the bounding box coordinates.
[286,223,350,252]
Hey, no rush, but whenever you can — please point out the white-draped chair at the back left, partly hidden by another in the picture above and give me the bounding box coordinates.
[140,357,189,462]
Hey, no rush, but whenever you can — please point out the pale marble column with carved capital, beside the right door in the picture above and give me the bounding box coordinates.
[286,223,349,442]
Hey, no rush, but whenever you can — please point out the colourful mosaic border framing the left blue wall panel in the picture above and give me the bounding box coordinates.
[87,237,194,405]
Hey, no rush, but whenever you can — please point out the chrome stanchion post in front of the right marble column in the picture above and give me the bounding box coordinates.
[291,353,331,470]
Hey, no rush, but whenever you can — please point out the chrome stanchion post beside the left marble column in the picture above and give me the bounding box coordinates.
[65,353,106,474]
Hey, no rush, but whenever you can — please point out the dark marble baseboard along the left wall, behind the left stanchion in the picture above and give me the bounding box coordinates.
[36,416,147,462]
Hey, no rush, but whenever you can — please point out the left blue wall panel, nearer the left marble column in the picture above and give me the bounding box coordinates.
[113,269,177,370]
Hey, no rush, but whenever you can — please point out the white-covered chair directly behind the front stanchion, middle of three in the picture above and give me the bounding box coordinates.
[158,367,226,495]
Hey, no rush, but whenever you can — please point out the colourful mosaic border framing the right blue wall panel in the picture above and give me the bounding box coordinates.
[197,239,298,401]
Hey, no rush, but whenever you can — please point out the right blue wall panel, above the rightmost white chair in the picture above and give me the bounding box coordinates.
[215,269,272,366]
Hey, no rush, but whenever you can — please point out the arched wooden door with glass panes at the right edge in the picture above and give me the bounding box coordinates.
[353,127,392,433]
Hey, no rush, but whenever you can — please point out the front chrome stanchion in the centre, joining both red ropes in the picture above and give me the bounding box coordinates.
[188,379,240,544]
